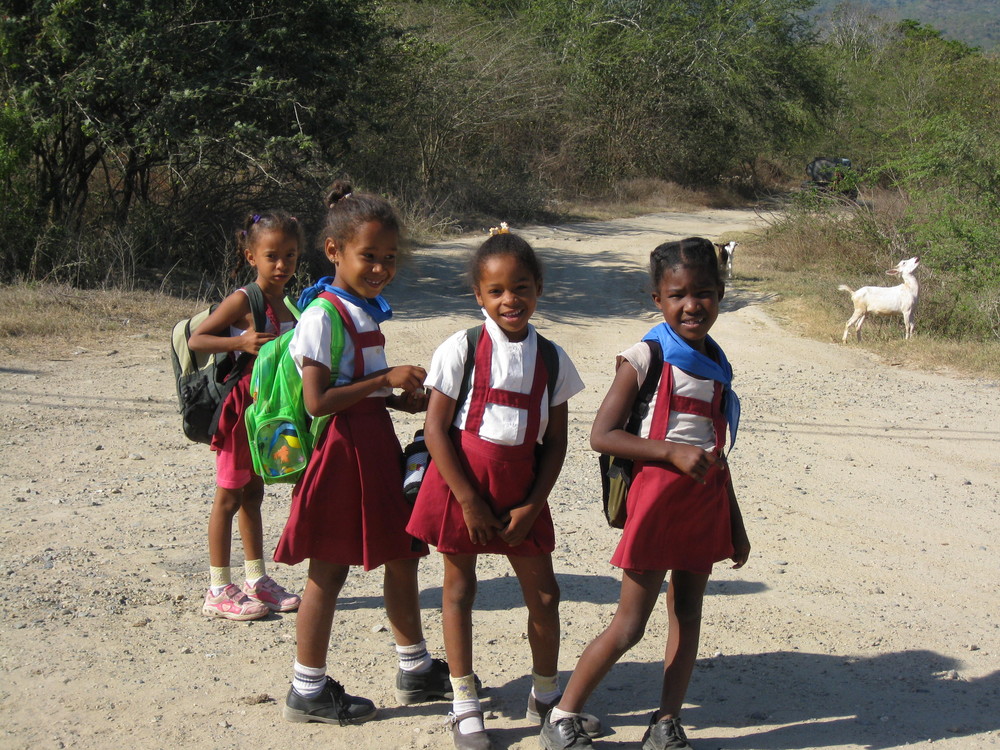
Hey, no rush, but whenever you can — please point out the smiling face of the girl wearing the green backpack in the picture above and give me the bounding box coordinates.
[325,221,399,299]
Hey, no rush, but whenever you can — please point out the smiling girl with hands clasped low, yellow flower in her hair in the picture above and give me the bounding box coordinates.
[407,227,583,750]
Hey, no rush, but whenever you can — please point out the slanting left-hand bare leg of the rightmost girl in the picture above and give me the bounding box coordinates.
[559,570,667,713]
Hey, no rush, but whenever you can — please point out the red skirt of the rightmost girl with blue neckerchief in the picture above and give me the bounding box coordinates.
[611,463,733,573]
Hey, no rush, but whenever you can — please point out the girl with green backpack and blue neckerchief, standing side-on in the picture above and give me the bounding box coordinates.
[274,181,451,725]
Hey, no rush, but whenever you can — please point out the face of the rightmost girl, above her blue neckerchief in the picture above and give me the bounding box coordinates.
[653,267,723,354]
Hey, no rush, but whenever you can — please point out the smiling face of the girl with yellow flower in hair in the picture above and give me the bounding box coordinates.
[472,255,542,341]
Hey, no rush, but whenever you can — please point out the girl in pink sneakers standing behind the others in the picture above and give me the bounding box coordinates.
[188,211,302,620]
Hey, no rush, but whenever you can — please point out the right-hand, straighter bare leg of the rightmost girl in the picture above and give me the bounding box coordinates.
[657,570,708,719]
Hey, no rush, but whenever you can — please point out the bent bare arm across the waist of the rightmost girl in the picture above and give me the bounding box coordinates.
[590,360,718,482]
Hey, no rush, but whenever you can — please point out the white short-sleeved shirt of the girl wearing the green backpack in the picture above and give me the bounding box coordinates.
[288,298,392,398]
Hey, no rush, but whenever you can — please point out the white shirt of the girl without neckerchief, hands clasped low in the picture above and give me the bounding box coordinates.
[424,317,584,445]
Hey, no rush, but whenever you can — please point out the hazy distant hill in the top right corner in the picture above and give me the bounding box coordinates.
[816,0,1000,52]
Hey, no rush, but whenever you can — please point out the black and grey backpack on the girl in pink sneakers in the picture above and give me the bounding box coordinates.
[170,282,267,443]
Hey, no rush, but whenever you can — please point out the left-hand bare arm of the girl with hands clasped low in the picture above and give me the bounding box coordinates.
[424,390,504,544]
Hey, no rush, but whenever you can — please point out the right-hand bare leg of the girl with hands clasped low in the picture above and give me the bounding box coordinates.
[507,555,559,675]
